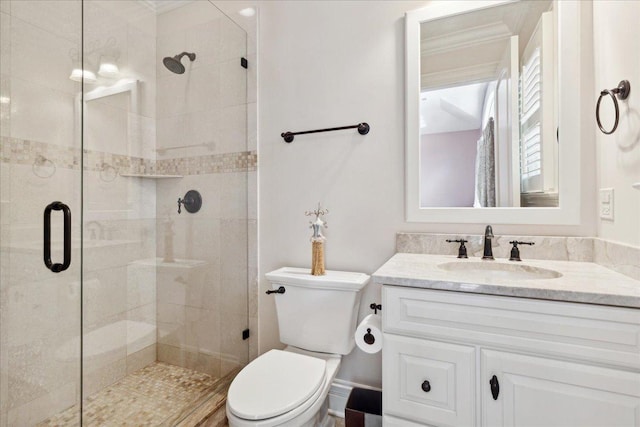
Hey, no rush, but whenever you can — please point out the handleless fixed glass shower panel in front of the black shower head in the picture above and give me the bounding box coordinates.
[77,0,248,426]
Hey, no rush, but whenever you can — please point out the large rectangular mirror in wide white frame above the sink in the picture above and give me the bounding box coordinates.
[406,0,581,224]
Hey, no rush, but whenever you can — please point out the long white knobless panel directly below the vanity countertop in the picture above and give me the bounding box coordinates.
[382,286,640,369]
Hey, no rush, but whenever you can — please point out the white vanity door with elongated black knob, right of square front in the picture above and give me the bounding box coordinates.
[480,350,640,427]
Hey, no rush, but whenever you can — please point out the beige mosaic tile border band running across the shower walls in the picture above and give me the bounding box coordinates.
[0,136,258,175]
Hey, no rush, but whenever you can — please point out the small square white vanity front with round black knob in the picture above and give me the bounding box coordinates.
[382,334,475,426]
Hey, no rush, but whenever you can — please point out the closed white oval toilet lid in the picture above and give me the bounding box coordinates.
[227,350,326,420]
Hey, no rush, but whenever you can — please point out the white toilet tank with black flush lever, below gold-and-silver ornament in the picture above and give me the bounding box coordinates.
[266,267,369,354]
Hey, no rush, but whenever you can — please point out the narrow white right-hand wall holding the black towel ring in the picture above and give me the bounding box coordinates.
[593,0,640,246]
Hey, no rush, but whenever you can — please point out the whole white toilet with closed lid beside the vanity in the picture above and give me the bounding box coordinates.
[226,267,369,427]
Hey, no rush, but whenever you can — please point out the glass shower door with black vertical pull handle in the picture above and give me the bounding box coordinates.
[0,0,82,427]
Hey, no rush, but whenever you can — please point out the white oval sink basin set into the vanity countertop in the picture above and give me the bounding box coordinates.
[438,261,562,280]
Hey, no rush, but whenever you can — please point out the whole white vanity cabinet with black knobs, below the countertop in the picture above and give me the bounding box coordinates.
[382,286,640,427]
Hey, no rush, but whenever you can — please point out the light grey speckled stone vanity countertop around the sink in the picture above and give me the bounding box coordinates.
[371,253,640,308]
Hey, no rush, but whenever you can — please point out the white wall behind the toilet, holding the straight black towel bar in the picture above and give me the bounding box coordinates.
[258,1,595,386]
